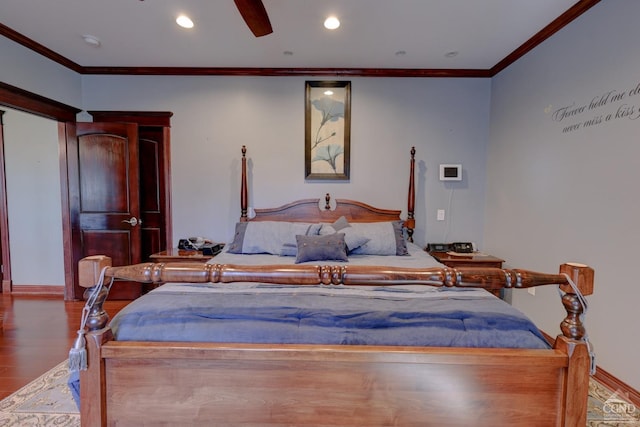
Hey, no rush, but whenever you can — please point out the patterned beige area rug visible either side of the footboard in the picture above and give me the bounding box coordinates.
[0,360,640,427]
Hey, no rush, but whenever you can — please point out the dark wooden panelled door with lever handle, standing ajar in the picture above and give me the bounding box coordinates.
[70,123,142,299]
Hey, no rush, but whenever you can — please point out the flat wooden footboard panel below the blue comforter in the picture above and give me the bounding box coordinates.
[82,336,588,427]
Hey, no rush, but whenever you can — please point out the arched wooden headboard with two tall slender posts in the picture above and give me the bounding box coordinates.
[240,146,416,242]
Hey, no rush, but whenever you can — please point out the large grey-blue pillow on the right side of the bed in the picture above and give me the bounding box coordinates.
[348,221,409,255]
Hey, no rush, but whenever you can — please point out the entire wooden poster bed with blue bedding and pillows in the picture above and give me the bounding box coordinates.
[74,147,593,426]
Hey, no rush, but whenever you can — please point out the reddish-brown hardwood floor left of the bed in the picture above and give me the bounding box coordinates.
[0,294,129,399]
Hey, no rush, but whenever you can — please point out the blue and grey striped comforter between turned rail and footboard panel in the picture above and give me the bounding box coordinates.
[111,284,548,348]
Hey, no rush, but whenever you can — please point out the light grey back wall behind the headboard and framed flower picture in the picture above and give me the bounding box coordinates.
[82,76,490,249]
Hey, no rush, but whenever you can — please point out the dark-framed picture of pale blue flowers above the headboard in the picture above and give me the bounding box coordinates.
[304,81,351,180]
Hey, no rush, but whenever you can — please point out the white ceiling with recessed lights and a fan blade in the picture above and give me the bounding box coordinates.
[0,0,599,75]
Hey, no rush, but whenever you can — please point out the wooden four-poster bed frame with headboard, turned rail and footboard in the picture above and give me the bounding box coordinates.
[79,147,593,427]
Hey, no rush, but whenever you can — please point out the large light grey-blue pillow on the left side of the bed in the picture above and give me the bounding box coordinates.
[228,221,320,255]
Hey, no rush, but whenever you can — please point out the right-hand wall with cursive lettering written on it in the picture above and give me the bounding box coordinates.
[485,0,640,389]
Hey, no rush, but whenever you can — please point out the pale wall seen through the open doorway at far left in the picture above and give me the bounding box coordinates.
[2,108,64,285]
